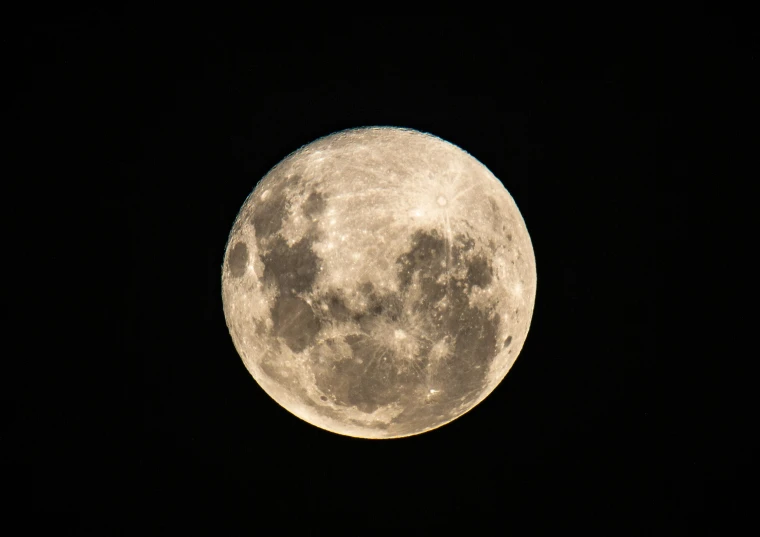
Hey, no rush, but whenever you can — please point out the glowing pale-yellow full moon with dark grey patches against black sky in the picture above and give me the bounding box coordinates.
[222,127,536,439]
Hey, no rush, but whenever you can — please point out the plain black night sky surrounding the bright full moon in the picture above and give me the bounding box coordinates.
[2,6,756,535]
